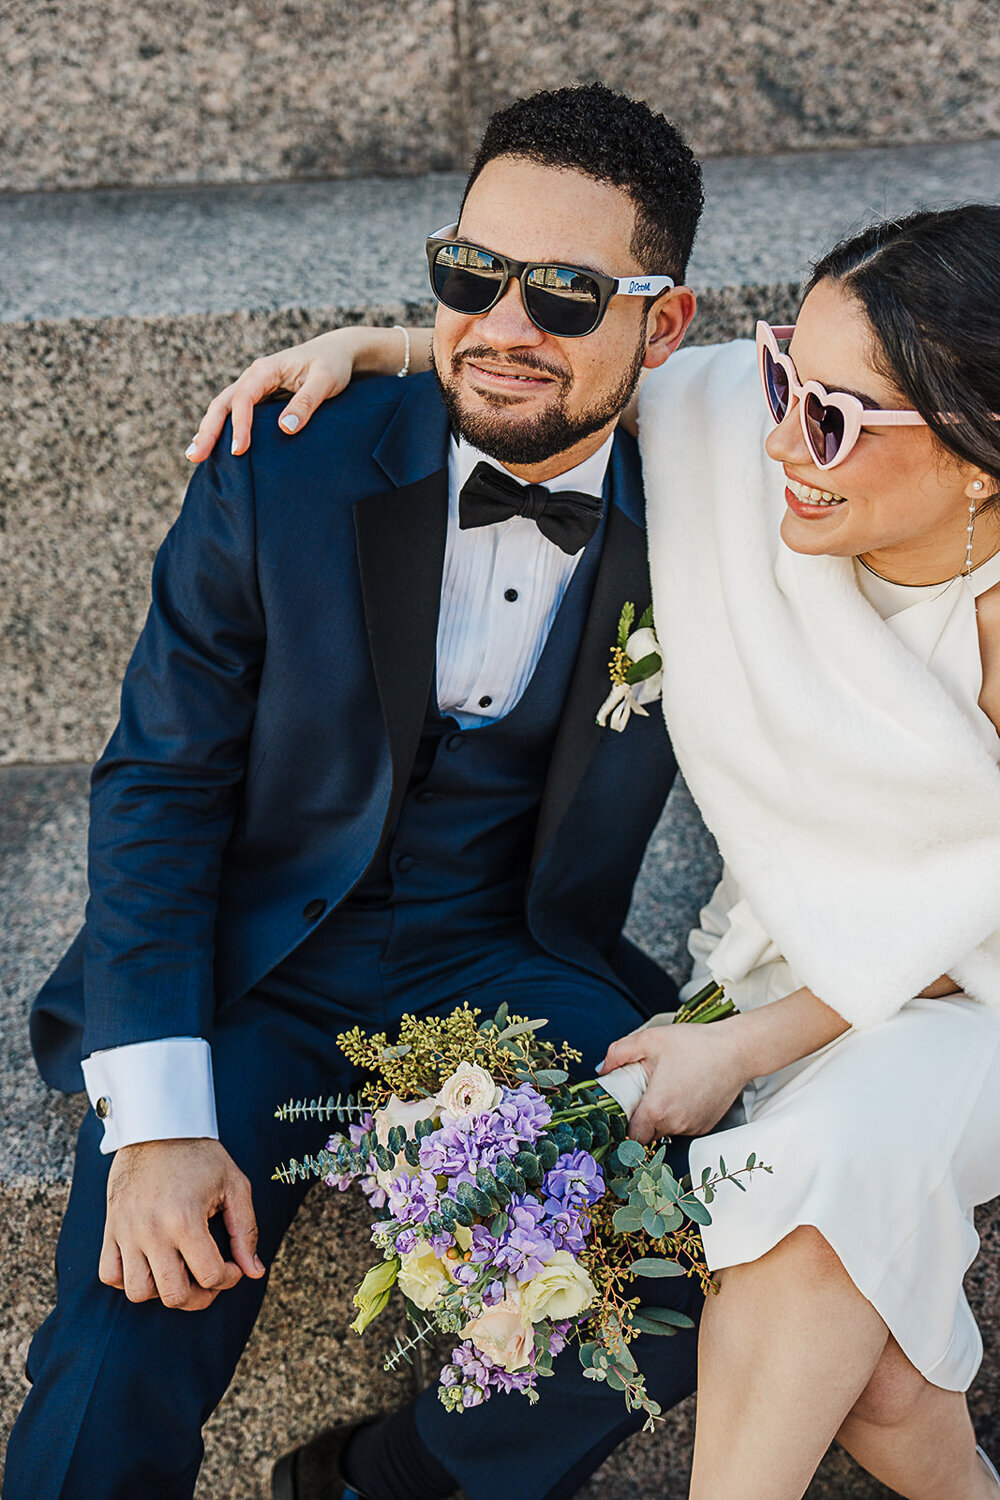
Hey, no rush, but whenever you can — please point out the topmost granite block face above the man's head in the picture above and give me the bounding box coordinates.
[0,0,1000,191]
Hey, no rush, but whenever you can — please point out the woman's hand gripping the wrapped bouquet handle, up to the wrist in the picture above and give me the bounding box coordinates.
[601,1020,748,1145]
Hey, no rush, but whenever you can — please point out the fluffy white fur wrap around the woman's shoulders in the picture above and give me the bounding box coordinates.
[640,342,1000,1026]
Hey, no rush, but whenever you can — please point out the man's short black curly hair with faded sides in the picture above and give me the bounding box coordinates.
[462,84,705,282]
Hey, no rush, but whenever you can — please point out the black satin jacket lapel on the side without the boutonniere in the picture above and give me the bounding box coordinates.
[354,470,448,828]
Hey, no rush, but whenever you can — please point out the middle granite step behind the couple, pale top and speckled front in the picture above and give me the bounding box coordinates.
[0,141,1000,764]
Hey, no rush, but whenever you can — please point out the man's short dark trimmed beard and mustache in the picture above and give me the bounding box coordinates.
[430,330,646,465]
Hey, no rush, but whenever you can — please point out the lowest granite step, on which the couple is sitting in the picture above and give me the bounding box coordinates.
[7,765,1000,1500]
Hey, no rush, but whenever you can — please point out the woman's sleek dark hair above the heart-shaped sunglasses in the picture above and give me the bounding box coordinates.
[807,203,1000,506]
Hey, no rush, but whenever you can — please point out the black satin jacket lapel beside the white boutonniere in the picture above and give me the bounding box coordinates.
[532,506,649,869]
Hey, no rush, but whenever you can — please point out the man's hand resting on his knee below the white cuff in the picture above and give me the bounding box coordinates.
[99,1140,264,1313]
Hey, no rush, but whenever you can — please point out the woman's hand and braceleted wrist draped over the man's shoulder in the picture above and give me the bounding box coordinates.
[186,327,430,464]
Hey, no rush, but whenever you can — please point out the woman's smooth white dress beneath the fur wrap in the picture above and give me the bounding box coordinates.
[682,555,1000,1391]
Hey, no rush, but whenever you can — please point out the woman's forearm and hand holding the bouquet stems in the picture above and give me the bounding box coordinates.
[601,990,849,1142]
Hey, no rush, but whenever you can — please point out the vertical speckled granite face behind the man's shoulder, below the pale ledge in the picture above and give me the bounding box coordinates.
[0,285,795,764]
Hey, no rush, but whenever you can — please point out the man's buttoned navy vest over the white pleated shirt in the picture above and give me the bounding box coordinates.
[340,515,606,939]
